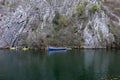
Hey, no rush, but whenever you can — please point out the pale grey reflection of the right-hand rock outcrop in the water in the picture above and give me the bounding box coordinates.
[85,50,110,80]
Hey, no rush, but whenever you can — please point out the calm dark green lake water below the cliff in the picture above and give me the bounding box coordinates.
[0,49,120,80]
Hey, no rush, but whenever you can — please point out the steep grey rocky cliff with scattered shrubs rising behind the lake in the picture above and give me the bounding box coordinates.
[0,0,120,48]
